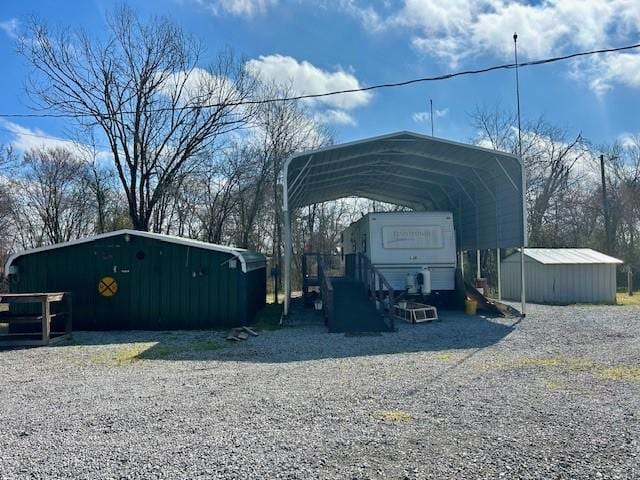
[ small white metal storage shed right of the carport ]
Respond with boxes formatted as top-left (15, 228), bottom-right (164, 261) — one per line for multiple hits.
top-left (501, 248), bottom-right (623, 305)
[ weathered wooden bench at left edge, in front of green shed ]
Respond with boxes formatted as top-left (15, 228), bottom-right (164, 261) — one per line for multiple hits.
top-left (0, 292), bottom-right (73, 347)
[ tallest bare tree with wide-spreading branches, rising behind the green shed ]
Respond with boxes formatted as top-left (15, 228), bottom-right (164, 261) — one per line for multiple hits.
top-left (19, 7), bottom-right (254, 230)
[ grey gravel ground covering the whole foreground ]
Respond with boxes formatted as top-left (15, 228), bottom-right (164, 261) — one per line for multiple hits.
top-left (0, 306), bottom-right (640, 479)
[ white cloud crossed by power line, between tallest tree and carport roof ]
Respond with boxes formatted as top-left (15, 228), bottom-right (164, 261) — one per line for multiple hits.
top-left (247, 55), bottom-right (372, 110)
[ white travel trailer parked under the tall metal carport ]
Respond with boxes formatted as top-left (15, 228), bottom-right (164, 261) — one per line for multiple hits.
top-left (342, 212), bottom-right (456, 294)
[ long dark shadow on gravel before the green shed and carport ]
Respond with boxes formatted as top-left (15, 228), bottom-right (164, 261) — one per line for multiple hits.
top-left (15, 302), bottom-right (515, 363)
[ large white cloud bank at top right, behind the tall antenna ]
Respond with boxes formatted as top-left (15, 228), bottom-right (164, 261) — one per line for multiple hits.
top-left (339, 0), bottom-right (640, 93)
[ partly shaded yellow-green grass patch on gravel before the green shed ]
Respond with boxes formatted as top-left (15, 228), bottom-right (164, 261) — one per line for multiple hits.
top-left (91, 340), bottom-right (224, 365)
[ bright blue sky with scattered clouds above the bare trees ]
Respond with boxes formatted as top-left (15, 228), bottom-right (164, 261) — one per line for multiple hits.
top-left (0, 0), bottom-right (640, 149)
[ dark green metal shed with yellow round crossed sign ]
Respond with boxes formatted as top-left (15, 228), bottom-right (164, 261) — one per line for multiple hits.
top-left (6, 230), bottom-right (266, 330)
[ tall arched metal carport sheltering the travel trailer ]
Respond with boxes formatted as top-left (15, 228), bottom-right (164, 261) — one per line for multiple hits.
top-left (283, 131), bottom-right (527, 315)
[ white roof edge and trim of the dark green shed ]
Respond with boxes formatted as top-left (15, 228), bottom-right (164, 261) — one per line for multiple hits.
top-left (5, 229), bottom-right (266, 275)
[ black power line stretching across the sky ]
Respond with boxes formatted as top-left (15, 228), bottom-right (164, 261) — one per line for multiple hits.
top-left (0, 43), bottom-right (640, 119)
